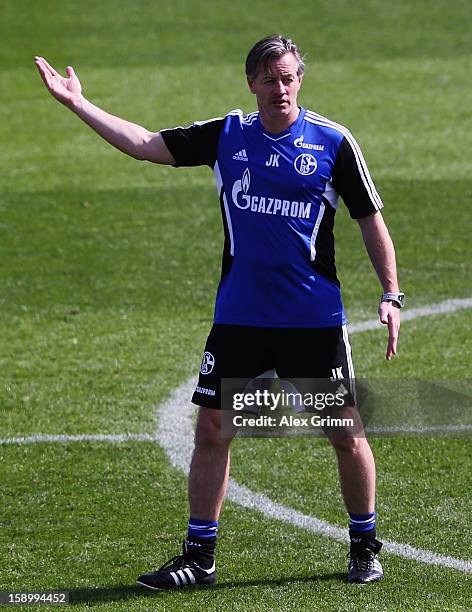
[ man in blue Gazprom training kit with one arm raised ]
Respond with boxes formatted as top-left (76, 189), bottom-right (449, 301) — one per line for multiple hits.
top-left (35, 36), bottom-right (404, 590)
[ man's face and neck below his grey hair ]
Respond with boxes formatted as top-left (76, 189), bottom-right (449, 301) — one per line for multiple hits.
top-left (248, 52), bottom-right (302, 132)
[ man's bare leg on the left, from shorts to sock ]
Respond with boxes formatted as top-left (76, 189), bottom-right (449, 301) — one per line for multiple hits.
top-left (188, 408), bottom-right (231, 521)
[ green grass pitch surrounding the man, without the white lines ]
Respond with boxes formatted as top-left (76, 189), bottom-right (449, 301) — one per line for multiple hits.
top-left (0, 0), bottom-right (472, 611)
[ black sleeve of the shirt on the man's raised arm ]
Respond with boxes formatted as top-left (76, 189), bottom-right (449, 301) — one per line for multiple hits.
top-left (161, 118), bottom-right (225, 168)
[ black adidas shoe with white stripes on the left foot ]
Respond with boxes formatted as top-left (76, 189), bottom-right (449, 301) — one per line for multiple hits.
top-left (136, 542), bottom-right (216, 591)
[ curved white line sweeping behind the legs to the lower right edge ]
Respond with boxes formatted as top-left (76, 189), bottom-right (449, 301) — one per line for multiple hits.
top-left (157, 378), bottom-right (472, 574)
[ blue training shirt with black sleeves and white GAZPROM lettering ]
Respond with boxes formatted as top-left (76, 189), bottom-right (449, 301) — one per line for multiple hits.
top-left (161, 108), bottom-right (383, 327)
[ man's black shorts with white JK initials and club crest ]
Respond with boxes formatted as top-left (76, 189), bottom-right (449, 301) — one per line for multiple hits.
top-left (192, 325), bottom-right (354, 408)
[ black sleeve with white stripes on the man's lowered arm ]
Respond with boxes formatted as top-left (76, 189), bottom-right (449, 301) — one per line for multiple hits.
top-left (332, 137), bottom-right (383, 219)
